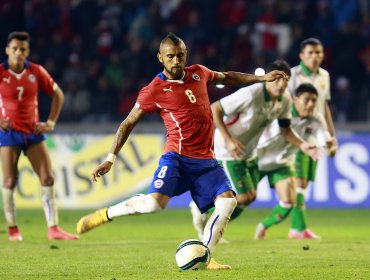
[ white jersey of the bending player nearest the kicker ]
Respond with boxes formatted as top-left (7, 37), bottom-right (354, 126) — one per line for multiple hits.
top-left (215, 83), bottom-right (292, 160)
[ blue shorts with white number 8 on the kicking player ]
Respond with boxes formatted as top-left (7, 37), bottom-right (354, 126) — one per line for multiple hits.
top-left (148, 152), bottom-right (232, 213)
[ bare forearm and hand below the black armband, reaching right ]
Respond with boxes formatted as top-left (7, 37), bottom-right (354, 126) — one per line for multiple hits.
top-left (280, 126), bottom-right (321, 160)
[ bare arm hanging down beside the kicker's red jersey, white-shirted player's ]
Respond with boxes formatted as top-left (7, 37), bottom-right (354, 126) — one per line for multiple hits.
top-left (211, 101), bottom-right (245, 160)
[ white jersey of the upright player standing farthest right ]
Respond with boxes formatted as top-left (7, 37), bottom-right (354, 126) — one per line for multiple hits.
top-left (288, 62), bottom-right (331, 116)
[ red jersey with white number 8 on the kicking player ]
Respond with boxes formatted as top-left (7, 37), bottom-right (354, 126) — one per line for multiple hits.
top-left (135, 65), bottom-right (217, 159)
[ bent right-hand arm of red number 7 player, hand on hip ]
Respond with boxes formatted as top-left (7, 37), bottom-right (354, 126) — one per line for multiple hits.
top-left (34, 84), bottom-right (64, 134)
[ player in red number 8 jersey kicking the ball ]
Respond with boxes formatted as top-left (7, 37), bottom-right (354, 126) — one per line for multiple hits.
top-left (77, 33), bottom-right (288, 270)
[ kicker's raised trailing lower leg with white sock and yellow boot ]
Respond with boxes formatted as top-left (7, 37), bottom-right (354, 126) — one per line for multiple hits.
top-left (77, 194), bottom-right (162, 233)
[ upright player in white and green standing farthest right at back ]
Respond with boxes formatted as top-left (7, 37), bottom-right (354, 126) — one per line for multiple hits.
top-left (288, 38), bottom-right (337, 239)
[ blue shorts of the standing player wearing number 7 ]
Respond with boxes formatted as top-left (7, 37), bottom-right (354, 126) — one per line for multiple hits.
top-left (0, 130), bottom-right (46, 153)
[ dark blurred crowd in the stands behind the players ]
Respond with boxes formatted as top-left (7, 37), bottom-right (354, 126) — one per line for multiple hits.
top-left (0, 0), bottom-right (370, 123)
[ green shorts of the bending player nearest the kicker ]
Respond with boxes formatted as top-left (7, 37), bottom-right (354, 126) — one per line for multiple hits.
top-left (218, 159), bottom-right (260, 194)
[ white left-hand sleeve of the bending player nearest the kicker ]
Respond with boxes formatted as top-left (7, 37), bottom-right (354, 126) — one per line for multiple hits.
top-left (219, 87), bottom-right (253, 116)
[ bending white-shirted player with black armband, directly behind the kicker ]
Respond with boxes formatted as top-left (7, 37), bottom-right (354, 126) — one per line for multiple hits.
top-left (190, 60), bottom-right (318, 241)
